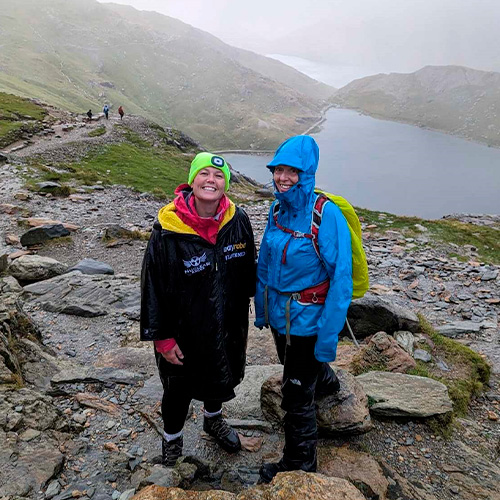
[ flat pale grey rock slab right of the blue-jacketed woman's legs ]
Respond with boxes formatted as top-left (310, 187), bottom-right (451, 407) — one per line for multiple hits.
top-left (356, 372), bottom-right (453, 418)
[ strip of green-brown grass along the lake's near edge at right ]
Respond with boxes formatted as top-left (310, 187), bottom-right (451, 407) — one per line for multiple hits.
top-left (356, 208), bottom-right (500, 264)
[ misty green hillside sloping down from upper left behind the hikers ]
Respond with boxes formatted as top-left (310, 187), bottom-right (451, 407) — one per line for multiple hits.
top-left (0, 0), bottom-right (335, 148)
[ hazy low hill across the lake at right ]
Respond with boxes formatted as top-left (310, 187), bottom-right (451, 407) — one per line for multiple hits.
top-left (334, 66), bottom-right (500, 146)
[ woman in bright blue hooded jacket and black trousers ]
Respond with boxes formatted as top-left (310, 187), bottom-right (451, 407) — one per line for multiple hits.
top-left (255, 135), bottom-right (352, 482)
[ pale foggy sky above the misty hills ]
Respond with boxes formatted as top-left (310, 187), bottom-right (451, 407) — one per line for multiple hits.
top-left (99, 0), bottom-right (500, 76)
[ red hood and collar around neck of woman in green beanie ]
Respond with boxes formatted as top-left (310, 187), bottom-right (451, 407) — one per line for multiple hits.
top-left (174, 184), bottom-right (229, 245)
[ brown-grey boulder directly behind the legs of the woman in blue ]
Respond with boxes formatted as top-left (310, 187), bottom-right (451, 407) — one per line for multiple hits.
top-left (261, 369), bottom-right (371, 436)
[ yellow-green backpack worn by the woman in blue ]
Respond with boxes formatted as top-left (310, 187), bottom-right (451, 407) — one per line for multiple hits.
top-left (311, 189), bottom-right (370, 299)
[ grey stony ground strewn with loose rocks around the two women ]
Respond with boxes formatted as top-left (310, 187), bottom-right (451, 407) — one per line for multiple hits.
top-left (0, 154), bottom-right (500, 500)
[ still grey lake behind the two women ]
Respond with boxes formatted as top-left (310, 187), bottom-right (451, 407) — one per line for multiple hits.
top-left (224, 109), bottom-right (500, 219)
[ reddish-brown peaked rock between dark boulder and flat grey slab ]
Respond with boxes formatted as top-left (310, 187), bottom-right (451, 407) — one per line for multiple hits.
top-left (351, 332), bottom-right (416, 374)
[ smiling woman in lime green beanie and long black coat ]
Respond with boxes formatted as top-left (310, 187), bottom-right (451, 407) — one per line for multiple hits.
top-left (140, 152), bottom-right (255, 467)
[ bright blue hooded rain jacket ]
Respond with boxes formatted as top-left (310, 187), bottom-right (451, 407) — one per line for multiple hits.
top-left (255, 135), bottom-right (352, 362)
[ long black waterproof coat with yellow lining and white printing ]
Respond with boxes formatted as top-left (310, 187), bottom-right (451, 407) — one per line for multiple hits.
top-left (141, 197), bottom-right (255, 401)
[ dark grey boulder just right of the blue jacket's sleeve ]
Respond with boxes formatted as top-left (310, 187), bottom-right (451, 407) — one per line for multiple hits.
top-left (341, 293), bottom-right (419, 337)
